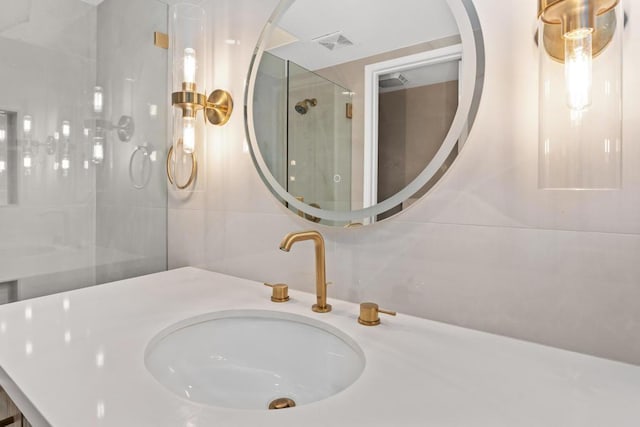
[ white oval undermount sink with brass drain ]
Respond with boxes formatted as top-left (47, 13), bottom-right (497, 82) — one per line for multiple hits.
top-left (145, 310), bottom-right (365, 410)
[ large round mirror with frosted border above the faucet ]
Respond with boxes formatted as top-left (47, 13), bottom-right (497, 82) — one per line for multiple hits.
top-left (245, 0), bottom-right (484, 226)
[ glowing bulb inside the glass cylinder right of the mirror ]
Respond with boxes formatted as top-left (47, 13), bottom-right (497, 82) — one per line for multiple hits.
top-left (564, 28), bottom-right (593, 111)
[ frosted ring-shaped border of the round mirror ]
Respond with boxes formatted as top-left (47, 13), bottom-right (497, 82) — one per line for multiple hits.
top-left (244, 0), bottom-right (485, 224)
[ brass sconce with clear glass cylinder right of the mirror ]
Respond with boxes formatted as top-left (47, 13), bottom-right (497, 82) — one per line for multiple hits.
top-left (538, 0), bottom-right (624, 190)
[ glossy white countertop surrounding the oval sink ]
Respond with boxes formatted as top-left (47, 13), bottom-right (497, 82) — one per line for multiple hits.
top-left (0, 268), bottom-right (640, 427)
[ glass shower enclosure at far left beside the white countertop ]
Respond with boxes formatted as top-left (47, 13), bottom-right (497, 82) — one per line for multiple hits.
top-left (0, 0), bottom-right (167, 304)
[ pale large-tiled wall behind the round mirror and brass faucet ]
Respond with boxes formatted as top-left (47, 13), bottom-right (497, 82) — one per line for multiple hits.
top-left (169, 0), bottom-right (640, 364)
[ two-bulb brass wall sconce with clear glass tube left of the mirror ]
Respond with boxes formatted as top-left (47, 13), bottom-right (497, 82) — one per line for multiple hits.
top-left (167, 3), bottom-right (233, 190)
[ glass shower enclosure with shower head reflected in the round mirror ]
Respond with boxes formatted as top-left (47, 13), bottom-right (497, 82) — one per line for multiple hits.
top-left (254, 52), bottom-right (353, 224)
